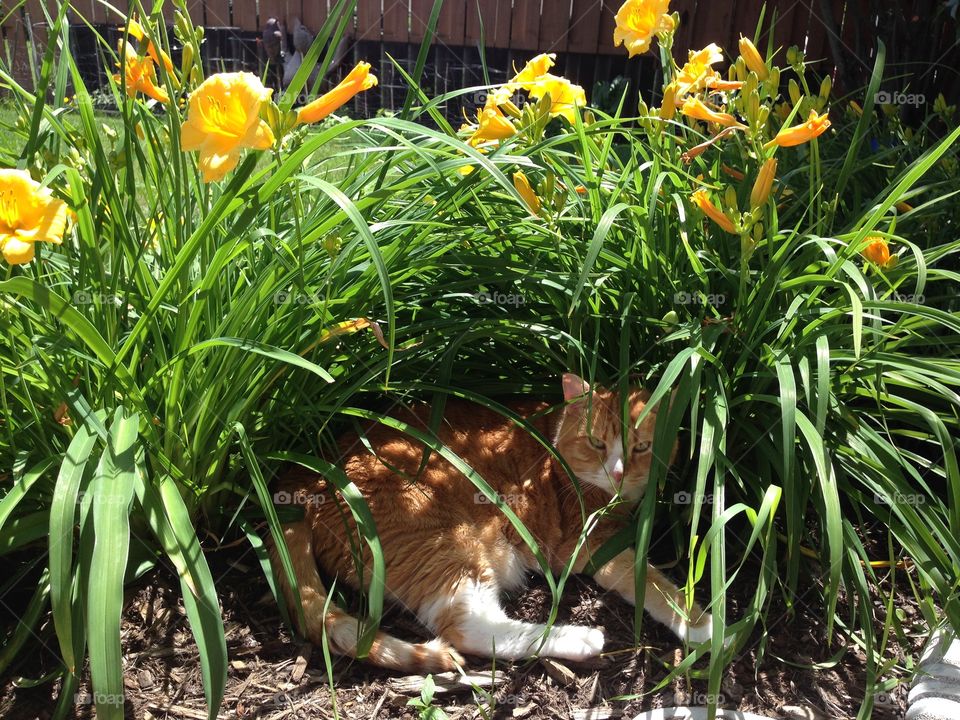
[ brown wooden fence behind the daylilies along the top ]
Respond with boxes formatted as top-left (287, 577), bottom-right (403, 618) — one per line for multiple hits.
top-left (0, 0), bottom-right (960, 118)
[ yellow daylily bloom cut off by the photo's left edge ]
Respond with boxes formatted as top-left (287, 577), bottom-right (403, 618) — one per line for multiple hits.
top-left (0, 168), bottom-right (72, 265)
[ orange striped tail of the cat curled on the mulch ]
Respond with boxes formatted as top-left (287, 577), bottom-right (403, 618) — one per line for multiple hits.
top-left (270, 521), bottom-right (465, 674)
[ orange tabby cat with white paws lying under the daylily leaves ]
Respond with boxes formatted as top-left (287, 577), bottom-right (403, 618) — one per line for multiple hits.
top-left (271, 374), bottom-right (712, 672)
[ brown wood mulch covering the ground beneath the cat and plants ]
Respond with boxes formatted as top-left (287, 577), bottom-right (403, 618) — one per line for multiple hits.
top-left (0, 547), bottom-right (925, 720)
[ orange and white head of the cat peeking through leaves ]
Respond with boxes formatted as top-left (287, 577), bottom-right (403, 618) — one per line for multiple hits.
top-left (555, 373), bottom-right (677, 501)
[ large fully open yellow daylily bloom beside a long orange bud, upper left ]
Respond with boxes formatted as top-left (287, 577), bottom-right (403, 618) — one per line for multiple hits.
top-left (180, 72), bottom-right (274, 182)
